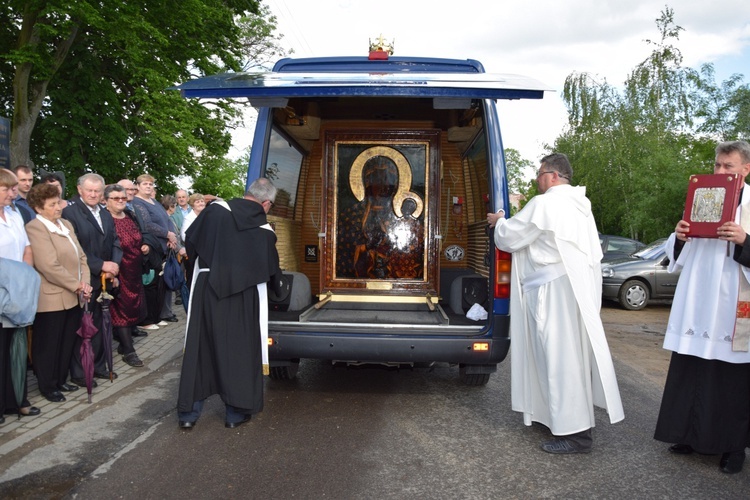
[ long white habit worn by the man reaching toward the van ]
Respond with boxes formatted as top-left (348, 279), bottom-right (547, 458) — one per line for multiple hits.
top-left (495, 184), bottom-right (625, 436)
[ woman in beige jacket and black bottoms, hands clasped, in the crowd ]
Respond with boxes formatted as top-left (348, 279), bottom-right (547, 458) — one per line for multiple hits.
top-left (26, 183), bottom-right (92, 403)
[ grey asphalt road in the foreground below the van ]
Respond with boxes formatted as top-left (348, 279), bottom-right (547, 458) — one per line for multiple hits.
top-left (0, 305), bottom-right (750, 499)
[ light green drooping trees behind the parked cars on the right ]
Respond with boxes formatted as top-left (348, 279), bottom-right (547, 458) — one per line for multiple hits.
top-left (554, 8), bottom-right (750, 242)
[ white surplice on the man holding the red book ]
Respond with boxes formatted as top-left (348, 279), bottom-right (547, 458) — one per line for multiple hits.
top-left (664, 184), bottom-right (750, 363)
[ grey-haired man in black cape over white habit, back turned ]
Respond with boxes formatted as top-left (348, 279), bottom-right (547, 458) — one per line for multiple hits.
top-left (177, 178), bottom-right (281, 429)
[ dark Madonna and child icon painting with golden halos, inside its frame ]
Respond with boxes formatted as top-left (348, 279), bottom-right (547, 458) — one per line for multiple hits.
top-left (336, 146), bottom-right (425, 280)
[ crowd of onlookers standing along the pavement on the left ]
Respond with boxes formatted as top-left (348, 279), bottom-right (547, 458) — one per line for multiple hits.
top-left (0, 165), bottom-right (205, 423)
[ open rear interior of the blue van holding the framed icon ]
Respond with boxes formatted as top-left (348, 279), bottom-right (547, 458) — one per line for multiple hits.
top-left (265, 96), bottom-right (490, 331)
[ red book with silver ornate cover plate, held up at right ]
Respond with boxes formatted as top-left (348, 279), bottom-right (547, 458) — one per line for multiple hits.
top-left (683, 174), bottom-right (743, 238)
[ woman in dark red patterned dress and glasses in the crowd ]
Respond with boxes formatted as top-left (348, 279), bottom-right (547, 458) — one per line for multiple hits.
top-left (104, 184), bottom-right (151, 367)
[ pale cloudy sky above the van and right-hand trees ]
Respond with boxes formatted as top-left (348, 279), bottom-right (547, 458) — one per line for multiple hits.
top-left (232, 0), bottom-right (750, 163)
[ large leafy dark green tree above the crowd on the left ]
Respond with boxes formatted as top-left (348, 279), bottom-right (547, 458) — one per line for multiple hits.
top-left (0, 0), bottom-right (288, 188)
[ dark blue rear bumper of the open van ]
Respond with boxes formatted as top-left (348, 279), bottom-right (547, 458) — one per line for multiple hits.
top-left (268, 315), bottom-right (510, 365)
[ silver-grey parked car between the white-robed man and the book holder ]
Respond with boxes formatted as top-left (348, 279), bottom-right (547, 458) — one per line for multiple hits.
top-left (602, 238), bottom-right (680, 311)
